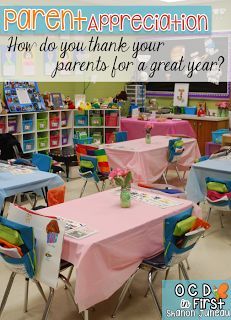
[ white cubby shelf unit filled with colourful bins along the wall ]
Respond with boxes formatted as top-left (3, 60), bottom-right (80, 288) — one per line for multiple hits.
top-left (0, 109), bottom-right (120, 153)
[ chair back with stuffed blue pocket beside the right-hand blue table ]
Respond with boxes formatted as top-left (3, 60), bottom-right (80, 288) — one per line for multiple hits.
top-left (205, 177), bottom-right (231, 211)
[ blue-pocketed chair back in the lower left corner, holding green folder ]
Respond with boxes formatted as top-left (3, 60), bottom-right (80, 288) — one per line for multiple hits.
top-left (0, 216), bottom-right (36, 278)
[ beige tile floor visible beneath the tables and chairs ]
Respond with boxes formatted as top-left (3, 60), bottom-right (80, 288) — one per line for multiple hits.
top-left (0, 176), bottom-right (231, 320)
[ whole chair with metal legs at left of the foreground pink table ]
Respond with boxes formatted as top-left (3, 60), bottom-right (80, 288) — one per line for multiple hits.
top-left (0, 211), bottom-right (76, 320)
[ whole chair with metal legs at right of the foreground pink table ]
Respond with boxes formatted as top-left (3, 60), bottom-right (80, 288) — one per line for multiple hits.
top-left (112, 208), bottom-right (209, 318)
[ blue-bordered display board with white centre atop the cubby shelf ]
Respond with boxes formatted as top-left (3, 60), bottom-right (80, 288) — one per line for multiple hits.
top-left (3, 81), bottom-right (46, 113)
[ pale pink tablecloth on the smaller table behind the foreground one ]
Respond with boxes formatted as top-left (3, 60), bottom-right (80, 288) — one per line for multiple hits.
top-left (105, 136), bottom-right (200, 183)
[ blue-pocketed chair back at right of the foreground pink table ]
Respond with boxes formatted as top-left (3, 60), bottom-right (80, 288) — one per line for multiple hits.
top-left (164, 207), bottom-right (205, 266)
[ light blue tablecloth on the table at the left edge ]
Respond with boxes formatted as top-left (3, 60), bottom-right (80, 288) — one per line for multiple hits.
top-left (0, 170), bottom-right (64, 208)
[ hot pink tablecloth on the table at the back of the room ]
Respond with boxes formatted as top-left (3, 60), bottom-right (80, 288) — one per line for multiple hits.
top-left (121, 118), bottom-right (196, 140)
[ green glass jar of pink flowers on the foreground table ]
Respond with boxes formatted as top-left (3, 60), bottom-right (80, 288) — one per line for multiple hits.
top-left (109, 169), bottom-right (132, 208)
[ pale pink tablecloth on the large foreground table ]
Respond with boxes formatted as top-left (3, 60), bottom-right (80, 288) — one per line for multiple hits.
top-left (41, 189), bottom-right (200, 311)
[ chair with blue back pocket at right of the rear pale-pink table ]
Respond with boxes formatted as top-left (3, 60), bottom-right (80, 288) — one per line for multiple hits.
top-left (163, 138), bottom-right (184, 184)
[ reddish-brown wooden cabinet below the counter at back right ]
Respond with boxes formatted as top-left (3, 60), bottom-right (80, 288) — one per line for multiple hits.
top-left (187, 119), bottom-right (229, 155)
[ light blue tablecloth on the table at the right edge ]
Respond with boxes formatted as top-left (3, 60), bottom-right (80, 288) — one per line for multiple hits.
top-left (186, 159), bottom-right (231, 203)
